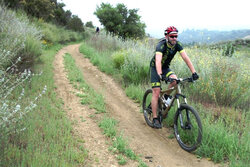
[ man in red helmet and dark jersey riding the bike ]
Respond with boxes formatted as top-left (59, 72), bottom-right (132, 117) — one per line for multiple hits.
top-left (150, 26), bottom-right (199, 128)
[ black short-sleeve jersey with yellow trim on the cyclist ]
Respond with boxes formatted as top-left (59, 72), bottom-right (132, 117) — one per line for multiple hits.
top-left (150, 38), bottom-right (184, 69)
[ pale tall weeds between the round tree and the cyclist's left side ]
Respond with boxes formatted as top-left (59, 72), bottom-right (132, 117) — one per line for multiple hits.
top-left (85, 34), bottom-right (153, 85)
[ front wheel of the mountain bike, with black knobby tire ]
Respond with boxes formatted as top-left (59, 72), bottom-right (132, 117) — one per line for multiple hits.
top-left (174, 104), bottom-right (202, 152)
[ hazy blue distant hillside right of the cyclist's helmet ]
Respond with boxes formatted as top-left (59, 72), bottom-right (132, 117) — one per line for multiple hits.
top-left (179, 29), bottom-right (250, 44)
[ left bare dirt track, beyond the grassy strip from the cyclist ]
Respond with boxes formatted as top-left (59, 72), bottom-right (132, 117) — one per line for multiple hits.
top-left (53, 46), bottom-right (137, 167)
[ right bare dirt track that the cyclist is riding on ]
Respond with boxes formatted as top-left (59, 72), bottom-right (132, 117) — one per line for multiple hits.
top-left (55, 44), bottom-right (223, 167)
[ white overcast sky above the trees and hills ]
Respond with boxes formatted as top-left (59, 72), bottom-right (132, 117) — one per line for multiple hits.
top-left (58, 0), bottom-right (250, 37)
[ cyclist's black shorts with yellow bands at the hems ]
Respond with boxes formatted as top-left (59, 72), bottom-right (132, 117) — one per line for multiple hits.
top-left (150, 67), bottom-right (174, 88)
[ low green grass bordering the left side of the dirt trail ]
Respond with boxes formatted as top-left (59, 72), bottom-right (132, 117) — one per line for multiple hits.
top-left (0, 46), bottom-right (87, 166)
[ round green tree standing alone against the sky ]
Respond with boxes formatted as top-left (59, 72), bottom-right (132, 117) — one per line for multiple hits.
top-left (94, 3), bottom-right (146, 39)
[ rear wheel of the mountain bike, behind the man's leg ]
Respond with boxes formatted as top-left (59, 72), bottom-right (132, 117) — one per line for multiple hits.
top-left (142, 89), bottom-right (160, 128)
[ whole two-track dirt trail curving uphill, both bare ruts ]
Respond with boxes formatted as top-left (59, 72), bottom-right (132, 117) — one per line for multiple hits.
top-left (54, 44), bottom-right (219, 167)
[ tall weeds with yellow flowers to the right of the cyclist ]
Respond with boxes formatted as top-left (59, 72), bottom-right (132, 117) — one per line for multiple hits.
top-left (168, 47), bottom-right (250, 110)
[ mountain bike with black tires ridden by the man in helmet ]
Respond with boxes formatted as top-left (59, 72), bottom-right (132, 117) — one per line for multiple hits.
top-left (142, 77), bottom-right (202, 152)
